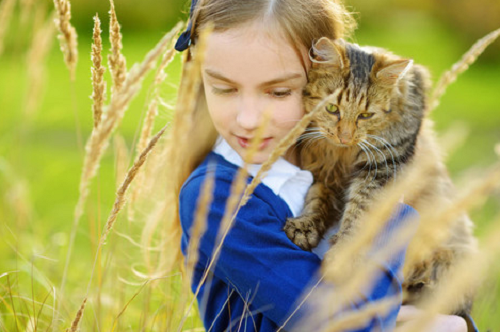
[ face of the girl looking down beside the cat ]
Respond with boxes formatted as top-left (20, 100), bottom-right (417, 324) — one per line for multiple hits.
top-left (202, 22), bottom-right (309, 164)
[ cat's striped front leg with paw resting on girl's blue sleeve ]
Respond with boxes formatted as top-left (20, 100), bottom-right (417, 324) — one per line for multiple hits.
top-left (284, 182), bottom-right (335, 250)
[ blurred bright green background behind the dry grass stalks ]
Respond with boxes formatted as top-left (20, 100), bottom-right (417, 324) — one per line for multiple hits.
top-left (0, 0), bottom-right (500, 331)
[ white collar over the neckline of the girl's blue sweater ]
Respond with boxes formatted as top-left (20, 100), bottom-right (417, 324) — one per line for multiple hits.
top-left (213, 136), bottom-right (313, 216)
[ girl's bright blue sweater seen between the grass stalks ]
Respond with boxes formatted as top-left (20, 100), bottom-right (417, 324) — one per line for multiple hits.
top-left (180, 168), bottom-right (413, 331)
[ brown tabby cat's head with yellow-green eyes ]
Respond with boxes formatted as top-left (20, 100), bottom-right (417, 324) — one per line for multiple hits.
top-left (304, 38), bottom-right (412, 147)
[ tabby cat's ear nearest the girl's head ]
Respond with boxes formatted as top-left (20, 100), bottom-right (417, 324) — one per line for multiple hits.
top-left (309, 37), bottom-right (345, 69)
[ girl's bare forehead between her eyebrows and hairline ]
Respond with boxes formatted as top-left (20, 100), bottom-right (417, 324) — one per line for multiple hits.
top-left (203, 24), bottom-right (309, 82)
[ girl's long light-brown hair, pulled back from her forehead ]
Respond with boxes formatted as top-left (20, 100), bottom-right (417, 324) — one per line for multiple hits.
top-left (148, 0), bottom-right (355, 269)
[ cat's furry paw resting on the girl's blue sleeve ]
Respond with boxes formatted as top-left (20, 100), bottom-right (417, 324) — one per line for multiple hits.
top-left (284, 215), bottom-right (321, 251)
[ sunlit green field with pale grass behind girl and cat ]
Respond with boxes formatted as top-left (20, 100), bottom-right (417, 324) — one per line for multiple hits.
top-left (0, 0), bottom-right (500, 332)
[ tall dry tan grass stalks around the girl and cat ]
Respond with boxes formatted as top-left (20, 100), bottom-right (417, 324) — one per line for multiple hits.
top-left (0, 0), bottom-right (500, 331)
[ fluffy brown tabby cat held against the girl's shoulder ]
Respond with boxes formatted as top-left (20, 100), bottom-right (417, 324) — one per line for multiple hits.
top-left (285, 38), bottom-right (476, 314)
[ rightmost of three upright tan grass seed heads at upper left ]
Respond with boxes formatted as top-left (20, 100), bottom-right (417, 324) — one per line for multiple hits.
top-left (108, 0), bottom-right (127, 94)
